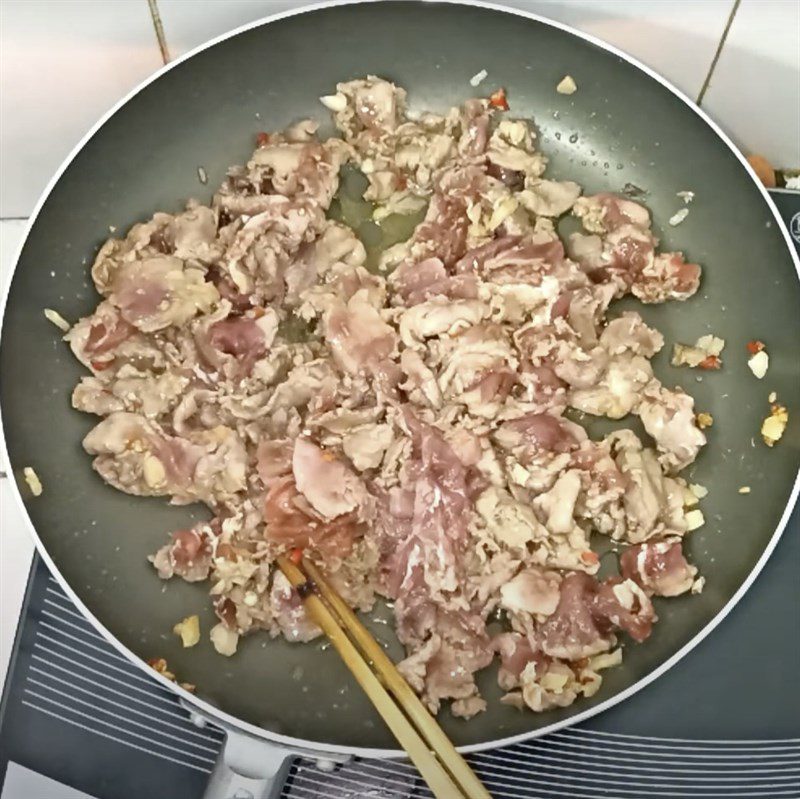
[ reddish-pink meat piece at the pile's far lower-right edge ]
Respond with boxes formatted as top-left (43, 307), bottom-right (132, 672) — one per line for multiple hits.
top-left (619, 541), bottom-right (697, 596)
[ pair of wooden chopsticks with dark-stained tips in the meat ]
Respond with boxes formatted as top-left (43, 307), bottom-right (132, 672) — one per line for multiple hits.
top-left (278, 557), bottom-right (491, 799)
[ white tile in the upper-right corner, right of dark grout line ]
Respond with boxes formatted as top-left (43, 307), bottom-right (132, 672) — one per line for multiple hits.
top-left (703, 0), bottom-right (800, 167)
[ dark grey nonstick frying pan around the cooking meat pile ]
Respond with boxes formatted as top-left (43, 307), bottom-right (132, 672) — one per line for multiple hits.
top-left (0, 2), bottom-right (800, 792)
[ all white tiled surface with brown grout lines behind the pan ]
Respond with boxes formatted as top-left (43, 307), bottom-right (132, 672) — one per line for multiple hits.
top-left (0, 0), bottom-right (800, 680)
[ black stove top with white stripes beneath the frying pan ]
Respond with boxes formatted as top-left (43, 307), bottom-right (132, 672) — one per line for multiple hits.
top-left (0, 192), bottom-right (800, 799)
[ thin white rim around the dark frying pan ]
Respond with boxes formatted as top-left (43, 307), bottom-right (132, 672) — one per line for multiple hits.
top-left (0, 0), bottom-right (800, 759)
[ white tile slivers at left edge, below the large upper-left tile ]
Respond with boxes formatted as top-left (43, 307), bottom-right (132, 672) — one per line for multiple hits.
top-left (0, 220), bottom-right (33, 685)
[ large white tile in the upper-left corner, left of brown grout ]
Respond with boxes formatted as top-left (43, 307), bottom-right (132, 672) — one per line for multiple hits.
top-left (0, 0), bottom-right (162, 217)
